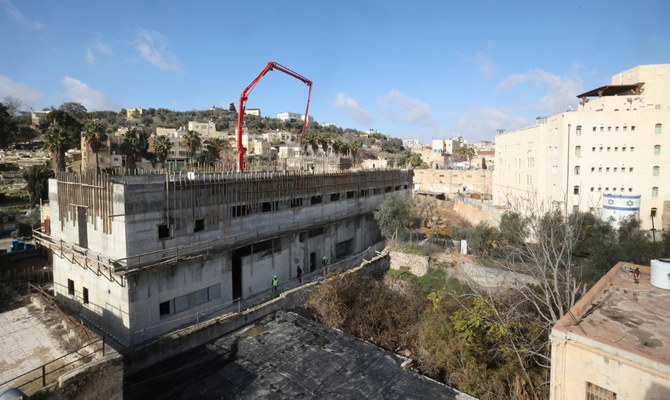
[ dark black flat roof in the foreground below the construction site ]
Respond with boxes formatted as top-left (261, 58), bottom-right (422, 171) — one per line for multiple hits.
top-left (124, 311), bottom-right (472, 400)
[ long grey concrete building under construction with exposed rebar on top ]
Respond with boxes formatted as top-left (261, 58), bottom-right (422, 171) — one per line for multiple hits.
top-left (38, 170), bottom-right (412, 346)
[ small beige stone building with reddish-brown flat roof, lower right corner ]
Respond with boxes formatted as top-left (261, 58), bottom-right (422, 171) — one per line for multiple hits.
top-left (550, 260), bottom-right (670, 400)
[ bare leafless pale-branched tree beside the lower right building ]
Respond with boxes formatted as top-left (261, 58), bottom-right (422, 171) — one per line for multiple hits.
top-left (454, 197), bottom-right (586, 398)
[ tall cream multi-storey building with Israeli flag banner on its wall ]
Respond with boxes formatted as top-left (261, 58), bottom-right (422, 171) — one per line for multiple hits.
top-left (493, 64), bottom-right (670, 230)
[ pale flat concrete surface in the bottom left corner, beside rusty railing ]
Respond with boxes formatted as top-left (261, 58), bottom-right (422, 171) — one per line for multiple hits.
top-left (0, 306), bottom-right (76, 393)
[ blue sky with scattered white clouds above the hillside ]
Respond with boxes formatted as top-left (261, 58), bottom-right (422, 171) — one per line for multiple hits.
top-left (0, 0), bottom-right (670, 142)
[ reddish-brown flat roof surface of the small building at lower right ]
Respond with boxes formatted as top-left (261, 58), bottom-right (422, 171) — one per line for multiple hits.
top-left (554, 262), bottom-right (670, 366)
